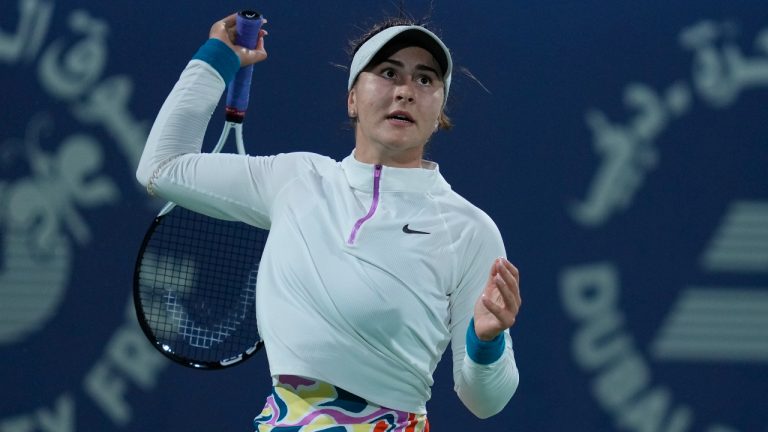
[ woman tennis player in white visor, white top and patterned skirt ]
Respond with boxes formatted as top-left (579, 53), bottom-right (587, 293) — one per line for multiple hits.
top-left (137, 11), bottom-right (521, 431)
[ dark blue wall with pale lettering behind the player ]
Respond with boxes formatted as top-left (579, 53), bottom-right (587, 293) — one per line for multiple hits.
top-left (0, 0), bottom-right (768, 432)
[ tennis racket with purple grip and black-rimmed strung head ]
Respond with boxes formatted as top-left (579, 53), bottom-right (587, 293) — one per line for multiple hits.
top-left (133, 11), bottom-right (267, 369)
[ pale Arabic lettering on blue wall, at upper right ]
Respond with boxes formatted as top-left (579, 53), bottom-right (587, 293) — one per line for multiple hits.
top-left (570, 21), bottom-right (768, 228)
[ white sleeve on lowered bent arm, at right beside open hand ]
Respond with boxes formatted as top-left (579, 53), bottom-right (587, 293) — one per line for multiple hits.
top-left (450, 215), bottom-right (519, 418)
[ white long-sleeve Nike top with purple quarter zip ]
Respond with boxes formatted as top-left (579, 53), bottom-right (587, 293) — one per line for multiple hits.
top-left (137, 41), bottom-right (518, 418)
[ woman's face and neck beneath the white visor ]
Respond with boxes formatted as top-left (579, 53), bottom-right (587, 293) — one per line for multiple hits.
top-left (347, 47), bottom-right (445, 167)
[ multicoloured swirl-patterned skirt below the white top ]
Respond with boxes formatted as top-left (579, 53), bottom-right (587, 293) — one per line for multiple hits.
top-left (253, 375), bottom-right (429, 432)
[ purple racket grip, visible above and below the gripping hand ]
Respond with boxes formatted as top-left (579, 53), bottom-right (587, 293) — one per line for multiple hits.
top-left (226, 10), bottom-right (264, 123)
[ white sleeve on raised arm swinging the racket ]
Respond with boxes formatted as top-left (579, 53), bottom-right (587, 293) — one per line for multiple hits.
top-left (136, 60), bottom-right (317, 229)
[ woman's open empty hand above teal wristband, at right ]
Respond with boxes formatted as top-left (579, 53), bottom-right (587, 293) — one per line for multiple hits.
top-left (475, 258), bottom-right (522, 341)
